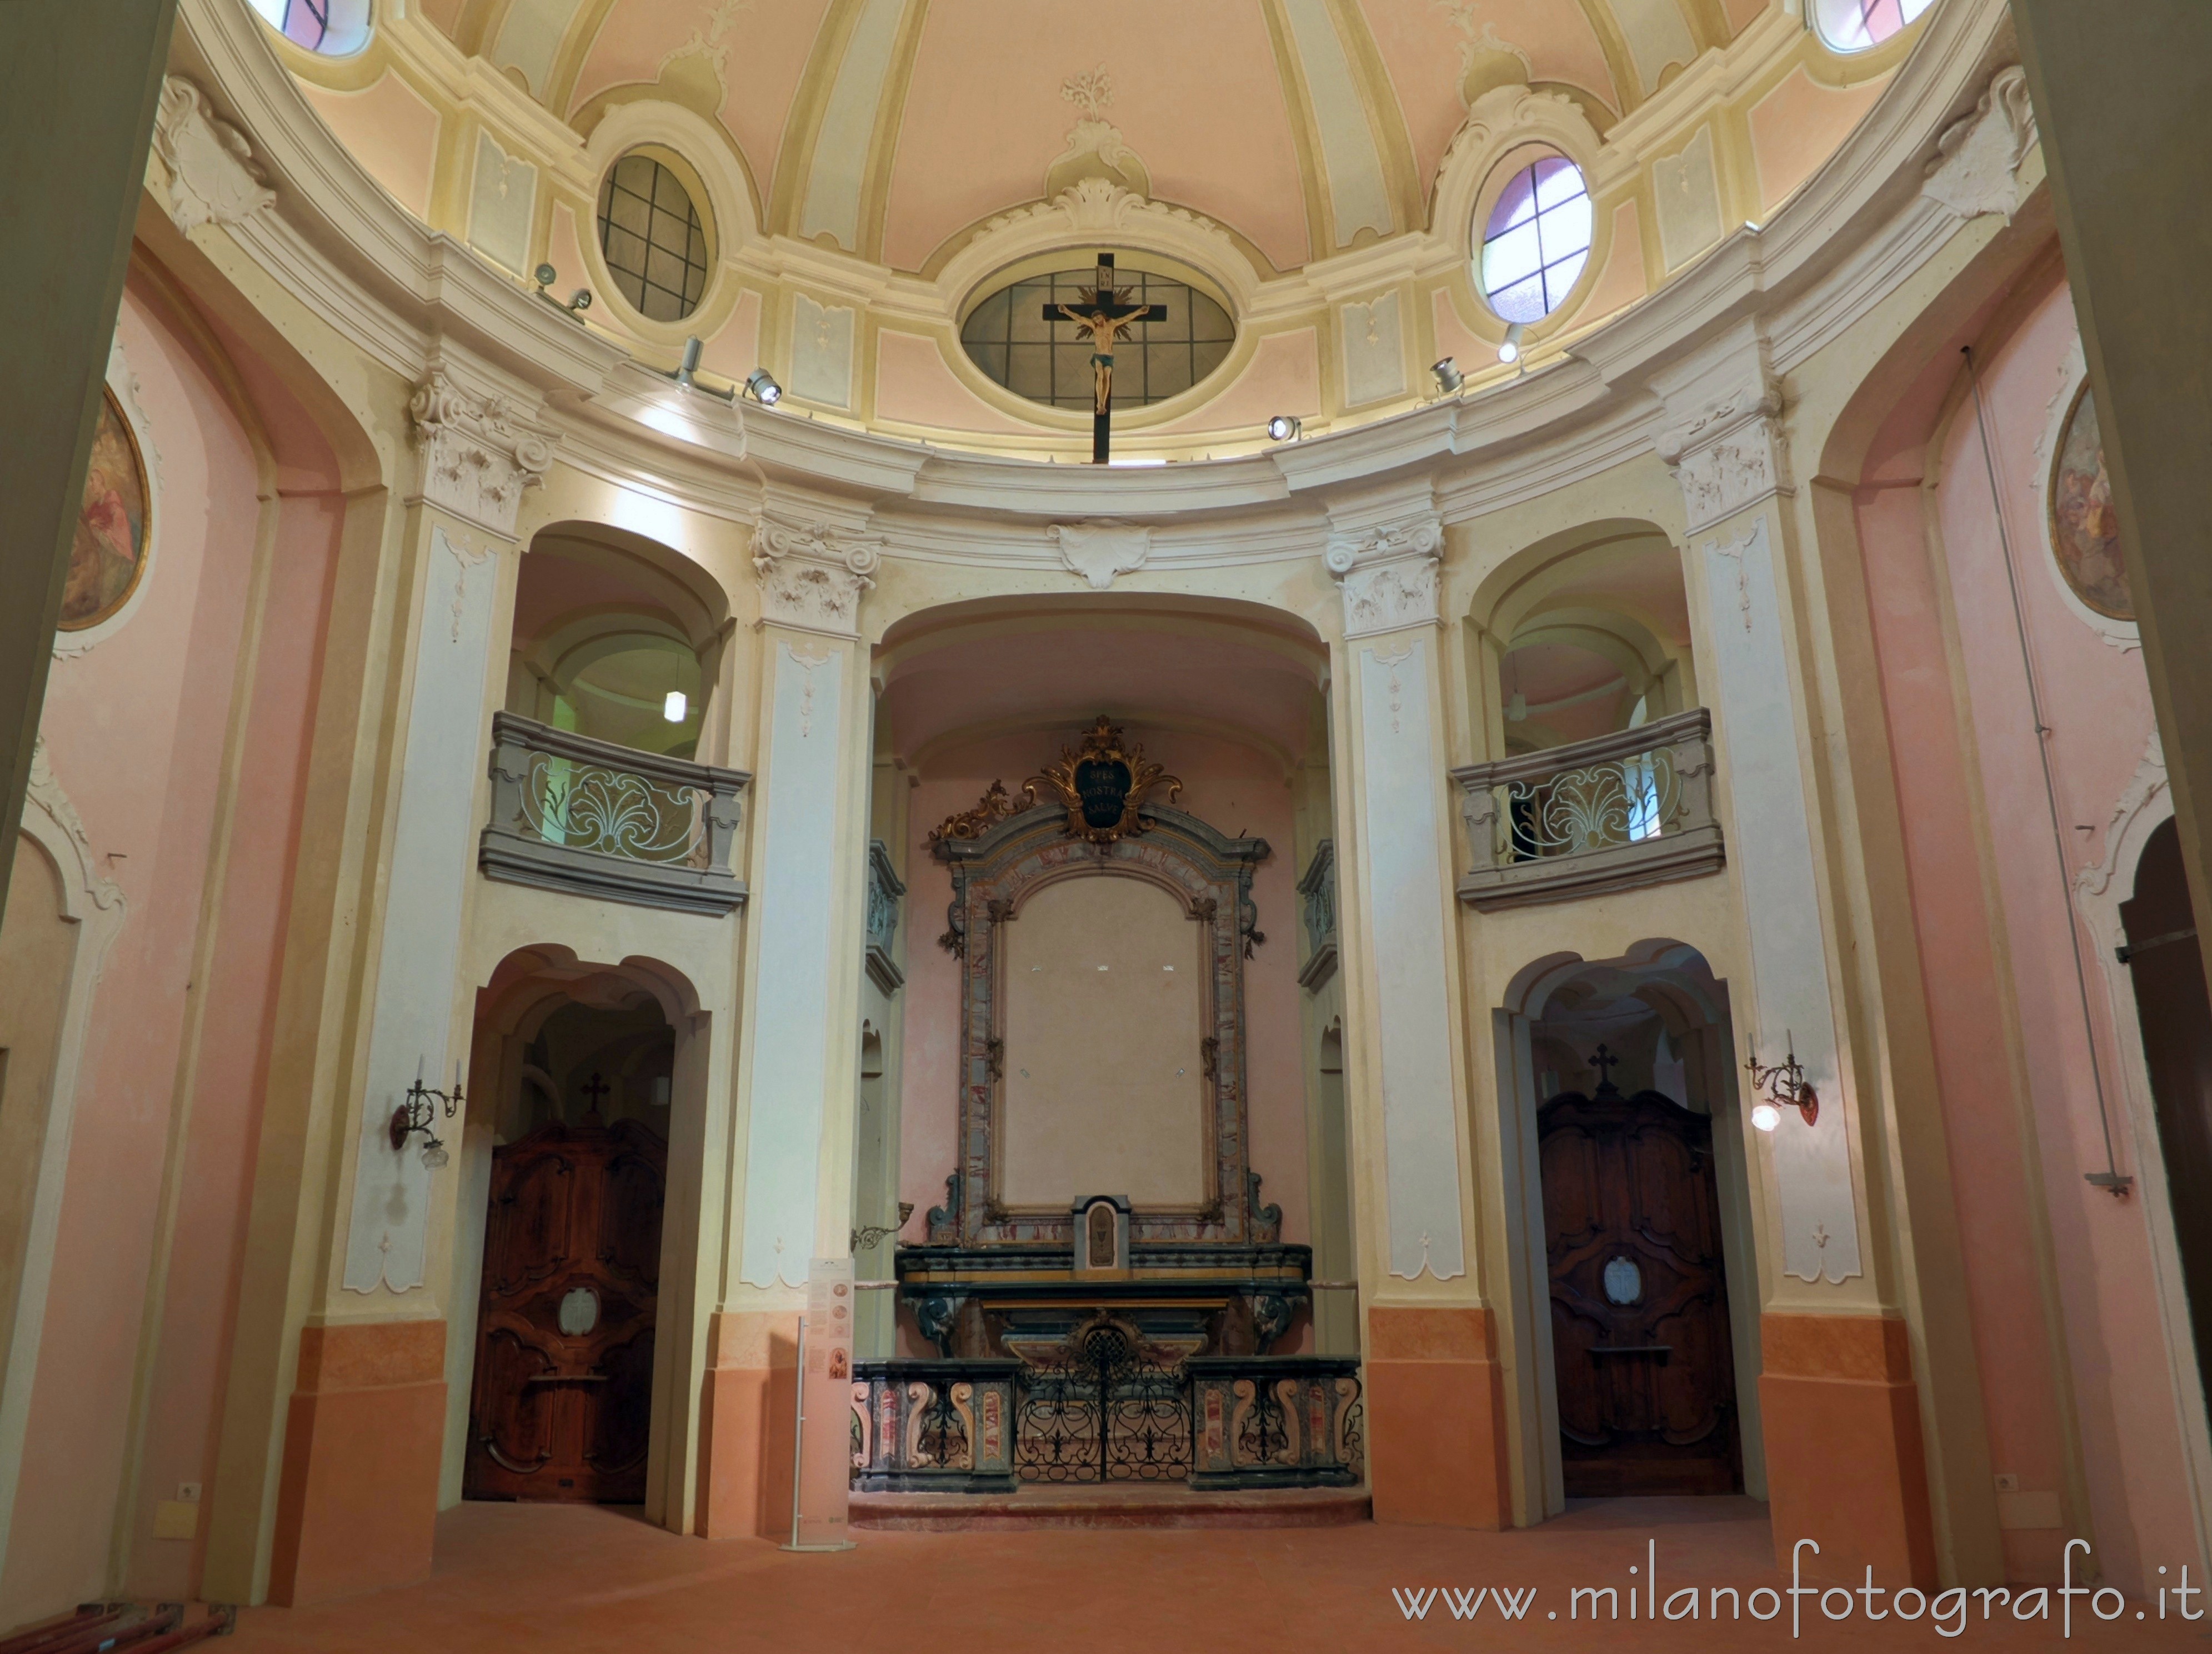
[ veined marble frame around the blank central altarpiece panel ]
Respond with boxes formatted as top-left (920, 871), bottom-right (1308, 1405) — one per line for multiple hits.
top-left (929, 805), bottom-right (1283, 1247)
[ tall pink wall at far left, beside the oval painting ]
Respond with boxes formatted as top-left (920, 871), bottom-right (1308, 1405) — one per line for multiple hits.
top-left (4, 278), bottom-right (341, 1612)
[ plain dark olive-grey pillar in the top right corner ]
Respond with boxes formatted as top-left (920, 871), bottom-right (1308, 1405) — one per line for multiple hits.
top-left (2013, 0), bottom-right (2212, 1012)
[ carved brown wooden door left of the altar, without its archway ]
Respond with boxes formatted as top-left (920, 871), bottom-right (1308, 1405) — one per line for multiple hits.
top-left (462, 1121), bottom-right (668, 1503)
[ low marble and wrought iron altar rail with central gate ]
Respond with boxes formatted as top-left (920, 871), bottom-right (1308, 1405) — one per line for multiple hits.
top-left (852, 1353), bottom-right (1365, 1492)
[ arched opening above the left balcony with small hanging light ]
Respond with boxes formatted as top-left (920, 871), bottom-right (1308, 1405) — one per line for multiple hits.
top-left (507, 524), bottom-right (725, 761)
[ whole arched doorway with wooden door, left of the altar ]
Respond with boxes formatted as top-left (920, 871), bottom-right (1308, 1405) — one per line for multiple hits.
top-left (447, 946), bottom-right (705, 1526)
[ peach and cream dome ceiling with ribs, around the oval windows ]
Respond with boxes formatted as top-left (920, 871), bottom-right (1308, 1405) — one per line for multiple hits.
top-left (281, 0), bottom-right (1918, 458)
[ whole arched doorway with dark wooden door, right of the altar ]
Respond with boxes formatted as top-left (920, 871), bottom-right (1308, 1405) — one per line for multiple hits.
top-left (1500, 942), bottom-right (1765, 1515)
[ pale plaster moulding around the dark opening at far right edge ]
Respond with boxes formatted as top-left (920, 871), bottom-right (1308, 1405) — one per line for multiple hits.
top-left (2073, 729), bottom-right (2212, 1557)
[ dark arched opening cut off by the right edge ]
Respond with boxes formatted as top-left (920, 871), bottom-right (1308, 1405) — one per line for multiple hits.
top-left (2119, 816), bottom-right (2212, 1376)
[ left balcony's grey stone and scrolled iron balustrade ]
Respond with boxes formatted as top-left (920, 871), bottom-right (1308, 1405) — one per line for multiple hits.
top-left (476, 712), bottom-right (752, 913)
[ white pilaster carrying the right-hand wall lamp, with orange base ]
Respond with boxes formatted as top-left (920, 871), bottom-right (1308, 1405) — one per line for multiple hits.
top-left (1657, 323), bottom-right (1935, 1586)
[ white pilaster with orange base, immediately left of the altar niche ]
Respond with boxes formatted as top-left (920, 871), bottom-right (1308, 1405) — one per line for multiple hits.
top-left (697, 511), bottom-right (880, 1539)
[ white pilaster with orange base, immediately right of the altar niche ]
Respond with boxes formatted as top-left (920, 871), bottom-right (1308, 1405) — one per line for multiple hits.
top-left (1325, 491), bottom-right (1513, 1528)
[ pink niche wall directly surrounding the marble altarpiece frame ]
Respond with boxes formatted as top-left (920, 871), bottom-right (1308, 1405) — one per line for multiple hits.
top-left (900, 723), bottom-right (1312, 1326)
